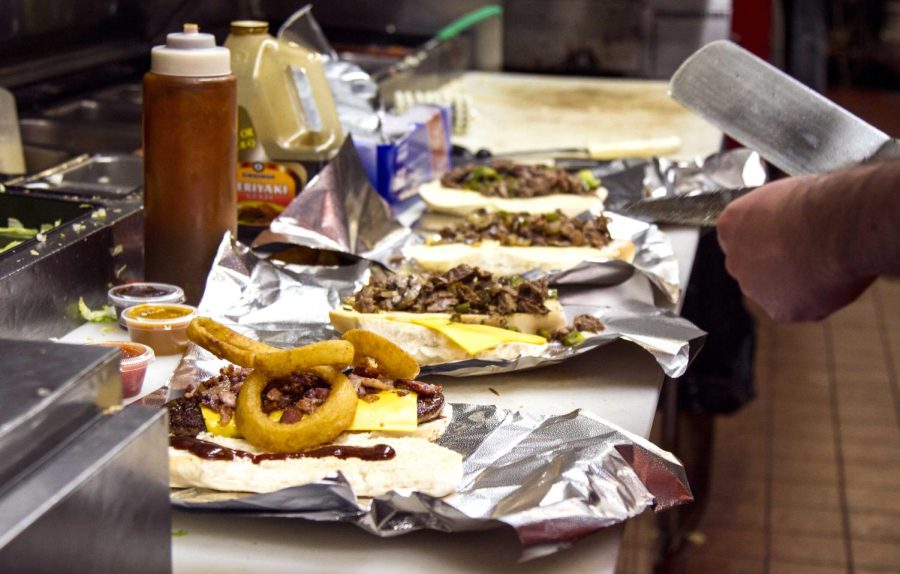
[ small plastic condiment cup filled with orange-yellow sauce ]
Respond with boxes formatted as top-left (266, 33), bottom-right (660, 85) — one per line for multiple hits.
top-left (122, 303), bottom-right (197, 355)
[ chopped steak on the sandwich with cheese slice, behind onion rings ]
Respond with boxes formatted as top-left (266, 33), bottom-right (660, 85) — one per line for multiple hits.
top-left (349, 265), bottom-right (550, 320)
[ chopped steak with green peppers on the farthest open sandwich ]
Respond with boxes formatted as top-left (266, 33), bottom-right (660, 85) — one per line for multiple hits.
top-left (441, 161), bottom-right (600, 197)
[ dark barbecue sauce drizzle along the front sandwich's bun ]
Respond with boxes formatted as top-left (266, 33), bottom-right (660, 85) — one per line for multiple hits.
top-left (169, 436), bottom-right (397, 464)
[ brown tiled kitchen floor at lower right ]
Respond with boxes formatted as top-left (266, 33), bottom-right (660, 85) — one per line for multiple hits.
top-left (618, 280), bottom-right (900, 574)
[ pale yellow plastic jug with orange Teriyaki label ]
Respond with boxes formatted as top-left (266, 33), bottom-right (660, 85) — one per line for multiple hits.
top-left (225, 20), bottom-right (344, 238)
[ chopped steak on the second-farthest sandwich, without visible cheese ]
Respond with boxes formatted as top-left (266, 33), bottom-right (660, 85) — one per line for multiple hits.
top-left (434, 210), bottom-right (612, 249)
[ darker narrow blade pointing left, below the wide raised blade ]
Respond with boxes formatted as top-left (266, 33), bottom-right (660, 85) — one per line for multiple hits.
top-left (618, 187), bottom-right (756, 227)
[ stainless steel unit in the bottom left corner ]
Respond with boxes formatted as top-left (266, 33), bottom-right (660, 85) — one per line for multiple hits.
top-left (0, 340), bottom-right (171, 574)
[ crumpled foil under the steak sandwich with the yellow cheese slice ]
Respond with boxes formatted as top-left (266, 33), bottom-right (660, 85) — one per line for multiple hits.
top-left (186, 235), bottom-right (705, 387)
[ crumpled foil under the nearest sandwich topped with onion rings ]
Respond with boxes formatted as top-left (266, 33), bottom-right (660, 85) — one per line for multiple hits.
top-left (172, 404), bottom-right (693, 560)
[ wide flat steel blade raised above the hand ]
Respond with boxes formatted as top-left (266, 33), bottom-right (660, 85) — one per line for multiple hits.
top-left (669, 40), bottom-right (900, 175)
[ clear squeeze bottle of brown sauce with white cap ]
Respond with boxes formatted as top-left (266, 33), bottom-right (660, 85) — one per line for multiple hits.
top-left (143, 24), bottom-right (237, 305)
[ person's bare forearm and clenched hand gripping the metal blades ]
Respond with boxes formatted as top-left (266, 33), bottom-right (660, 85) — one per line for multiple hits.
top-left (717, 161), bottom-right (900, 321)
